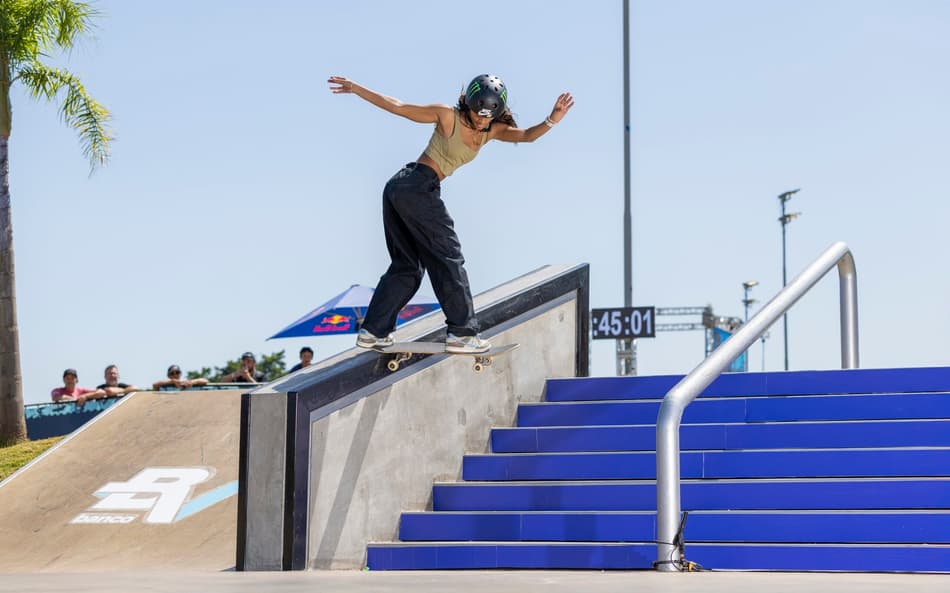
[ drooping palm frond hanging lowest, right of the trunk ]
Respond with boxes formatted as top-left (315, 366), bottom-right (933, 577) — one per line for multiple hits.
top-left (19, 62), bottom-right (113, 170)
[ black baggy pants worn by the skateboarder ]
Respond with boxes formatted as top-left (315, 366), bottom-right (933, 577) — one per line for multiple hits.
top-left (363, 163), bottom-right (478, 337)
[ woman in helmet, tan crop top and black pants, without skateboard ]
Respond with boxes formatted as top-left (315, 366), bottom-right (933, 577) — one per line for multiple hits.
top-left (328, 74), bottom-right (574, 353)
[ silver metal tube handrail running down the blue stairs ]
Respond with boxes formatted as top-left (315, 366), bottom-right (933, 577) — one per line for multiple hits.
top-left (656, 242), bottom-right (858, 571)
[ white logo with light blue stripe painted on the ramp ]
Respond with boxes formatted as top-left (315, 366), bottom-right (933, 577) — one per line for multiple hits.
top-left (70, 467), bottom-right (237, 524)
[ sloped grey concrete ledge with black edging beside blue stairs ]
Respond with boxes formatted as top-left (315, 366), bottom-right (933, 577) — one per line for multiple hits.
top-left (237, 264), bottom-right (590, 570)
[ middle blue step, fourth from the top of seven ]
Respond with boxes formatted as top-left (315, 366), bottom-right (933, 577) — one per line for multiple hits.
top-left (462, 449), bottom-right (950, 481)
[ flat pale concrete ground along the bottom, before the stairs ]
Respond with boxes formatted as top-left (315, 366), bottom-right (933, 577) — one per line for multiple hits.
top-left (0, 570), bottom-right (950, 593)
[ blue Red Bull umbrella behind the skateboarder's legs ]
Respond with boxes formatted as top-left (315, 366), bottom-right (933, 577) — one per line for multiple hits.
top-left (267, 284), bottom-right (439, 340)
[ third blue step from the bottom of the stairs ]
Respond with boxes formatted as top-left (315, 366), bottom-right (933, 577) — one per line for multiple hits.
top-left (432, 478), bottom-right (950, 511)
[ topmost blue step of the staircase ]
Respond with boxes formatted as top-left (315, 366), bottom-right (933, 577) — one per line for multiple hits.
top-left (544, 367), bottom-right (950, 402)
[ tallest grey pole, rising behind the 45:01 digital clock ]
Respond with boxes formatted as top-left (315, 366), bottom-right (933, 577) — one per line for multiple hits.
top-left (617, 0), bottom-right (637, 375)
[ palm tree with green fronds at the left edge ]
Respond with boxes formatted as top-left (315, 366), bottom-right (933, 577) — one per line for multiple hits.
top-left (0, 0), bottom-right (112, 443)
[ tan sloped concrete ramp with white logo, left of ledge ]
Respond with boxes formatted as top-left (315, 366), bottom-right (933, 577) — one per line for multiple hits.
top-left (0, 391), bottom-right (241, 572)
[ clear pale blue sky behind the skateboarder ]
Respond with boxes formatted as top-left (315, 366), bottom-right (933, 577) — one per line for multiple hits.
top-left (11, 0), bottom-right (950, 403)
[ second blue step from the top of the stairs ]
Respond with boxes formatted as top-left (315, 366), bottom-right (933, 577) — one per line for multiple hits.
top-left (518, 393), bottom-right (950, 426)
